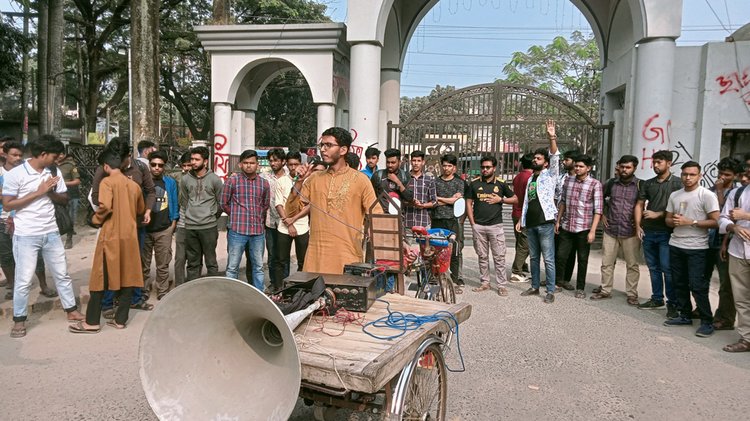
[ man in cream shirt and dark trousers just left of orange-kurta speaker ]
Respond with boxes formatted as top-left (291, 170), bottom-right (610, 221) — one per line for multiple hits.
top-left (270, 151), bottom-right (310, 291)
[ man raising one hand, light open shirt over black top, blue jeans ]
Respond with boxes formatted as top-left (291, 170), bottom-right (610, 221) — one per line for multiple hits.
top-left (515, 120), bottom-right (560, 303)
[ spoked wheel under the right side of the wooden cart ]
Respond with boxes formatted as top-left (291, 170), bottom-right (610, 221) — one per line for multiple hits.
top-left (389, 336), bottom-right (448, 421)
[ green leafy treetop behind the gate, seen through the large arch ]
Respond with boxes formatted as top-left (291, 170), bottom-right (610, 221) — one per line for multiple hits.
top-left (499, 31), bottom-right (601, 116)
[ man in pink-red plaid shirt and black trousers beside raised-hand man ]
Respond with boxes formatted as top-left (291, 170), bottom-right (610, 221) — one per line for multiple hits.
top-left (555, 155), bottom-right (603, 298)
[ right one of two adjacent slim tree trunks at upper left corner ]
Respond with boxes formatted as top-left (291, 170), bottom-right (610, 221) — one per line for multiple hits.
top-left (46, 0), bottom-right (65, 137)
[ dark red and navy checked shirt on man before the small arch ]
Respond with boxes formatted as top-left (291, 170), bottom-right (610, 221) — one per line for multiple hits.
top-left (221, 173), bottom-right (271, 235)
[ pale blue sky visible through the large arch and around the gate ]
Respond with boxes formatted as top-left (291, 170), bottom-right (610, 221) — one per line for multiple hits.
top-left (0, 0), bottom-right (750, 97)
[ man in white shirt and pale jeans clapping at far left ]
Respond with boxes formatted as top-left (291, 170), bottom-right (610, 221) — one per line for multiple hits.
top-left (3, 139), bottom-right (84, 338)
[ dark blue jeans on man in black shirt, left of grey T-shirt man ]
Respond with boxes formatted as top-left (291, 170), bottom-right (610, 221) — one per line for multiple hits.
top-left (643, 231), bottom-right (680, 304)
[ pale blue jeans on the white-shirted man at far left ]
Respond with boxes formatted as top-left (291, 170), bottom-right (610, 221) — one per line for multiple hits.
top-left (13, 232), bottom-right (77, 322)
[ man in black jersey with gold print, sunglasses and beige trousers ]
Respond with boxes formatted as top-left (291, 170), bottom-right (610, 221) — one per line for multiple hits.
top-left (466, 156), bottom-right (518, 297)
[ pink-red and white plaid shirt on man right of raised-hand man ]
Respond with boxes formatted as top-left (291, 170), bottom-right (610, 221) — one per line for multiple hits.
top-left (560, 175), bottom-right (603, 233)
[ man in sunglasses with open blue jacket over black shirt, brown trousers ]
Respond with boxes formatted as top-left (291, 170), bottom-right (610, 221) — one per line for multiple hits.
top-left (141, 151), bottom-right (180, 300)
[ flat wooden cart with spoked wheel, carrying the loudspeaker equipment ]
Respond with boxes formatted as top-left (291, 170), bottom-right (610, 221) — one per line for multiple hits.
top-left (295, 294), bottom-right (471, 420)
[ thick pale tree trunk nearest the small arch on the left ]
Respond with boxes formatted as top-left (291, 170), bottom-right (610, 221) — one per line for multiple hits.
top-left (130, 0), bottom-right (160, 145)
